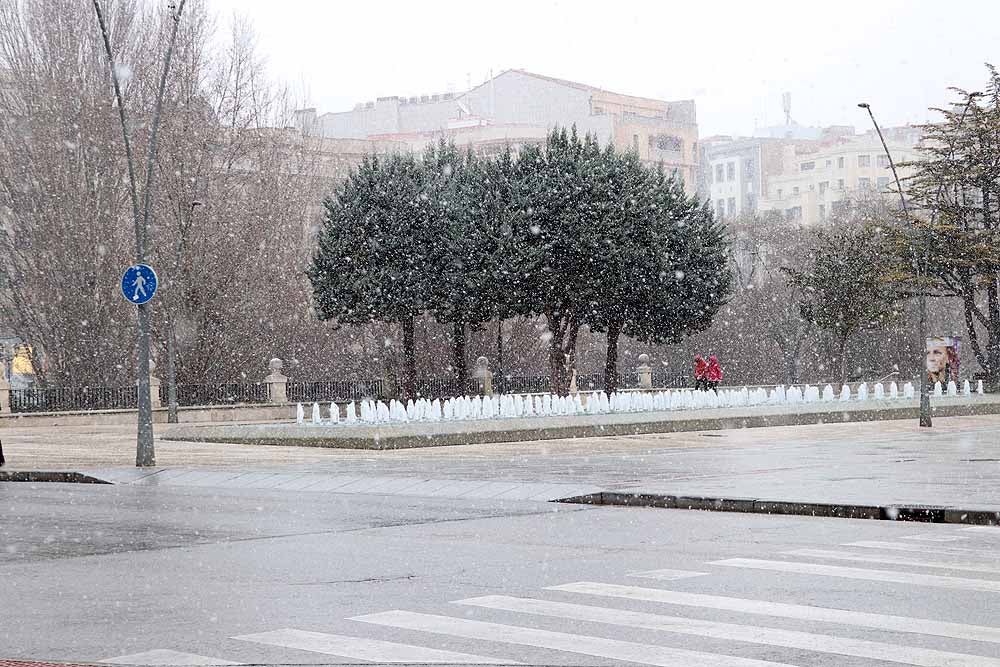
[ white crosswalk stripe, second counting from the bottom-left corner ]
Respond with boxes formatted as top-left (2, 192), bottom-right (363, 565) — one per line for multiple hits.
top-left (233, 628), bottom-right (521, 665)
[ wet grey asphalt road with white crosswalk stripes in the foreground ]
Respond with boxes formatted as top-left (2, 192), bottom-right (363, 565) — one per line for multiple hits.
top-left (0, 483), bottom-right (1000, 666)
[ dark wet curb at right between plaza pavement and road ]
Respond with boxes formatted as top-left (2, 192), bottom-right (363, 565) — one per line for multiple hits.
top-left (554, 491), bottom-right (1000, 526)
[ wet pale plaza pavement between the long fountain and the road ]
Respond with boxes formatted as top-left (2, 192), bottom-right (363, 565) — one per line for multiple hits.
top-left (0, 415), bottom-right (1000, 512)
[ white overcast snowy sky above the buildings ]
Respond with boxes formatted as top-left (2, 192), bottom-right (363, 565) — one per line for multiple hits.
top-left (207, 0), bottom-right (1000, 136)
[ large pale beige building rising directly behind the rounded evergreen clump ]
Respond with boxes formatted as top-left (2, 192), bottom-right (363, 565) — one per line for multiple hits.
top-left (295, 70), bottom-right (698, 193)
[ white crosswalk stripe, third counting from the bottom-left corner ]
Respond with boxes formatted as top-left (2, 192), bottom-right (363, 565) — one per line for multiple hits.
top-left (351, 610), bottom-right (789, 667)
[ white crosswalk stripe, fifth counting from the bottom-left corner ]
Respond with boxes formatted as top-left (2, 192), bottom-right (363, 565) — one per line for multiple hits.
top-left (547, 581), bottom-right (1000, 644)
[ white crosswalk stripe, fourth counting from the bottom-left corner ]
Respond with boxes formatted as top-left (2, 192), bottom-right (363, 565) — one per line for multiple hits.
top-left (457, 595), bottom-right (1000, 667)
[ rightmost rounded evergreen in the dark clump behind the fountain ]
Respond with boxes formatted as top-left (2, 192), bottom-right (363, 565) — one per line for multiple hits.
top-left (587, 155), bottom-right (733, 393)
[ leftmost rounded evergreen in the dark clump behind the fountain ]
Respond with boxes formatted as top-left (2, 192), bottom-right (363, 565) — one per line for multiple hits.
top-left (307, 154), bottom-right (435, 397)
